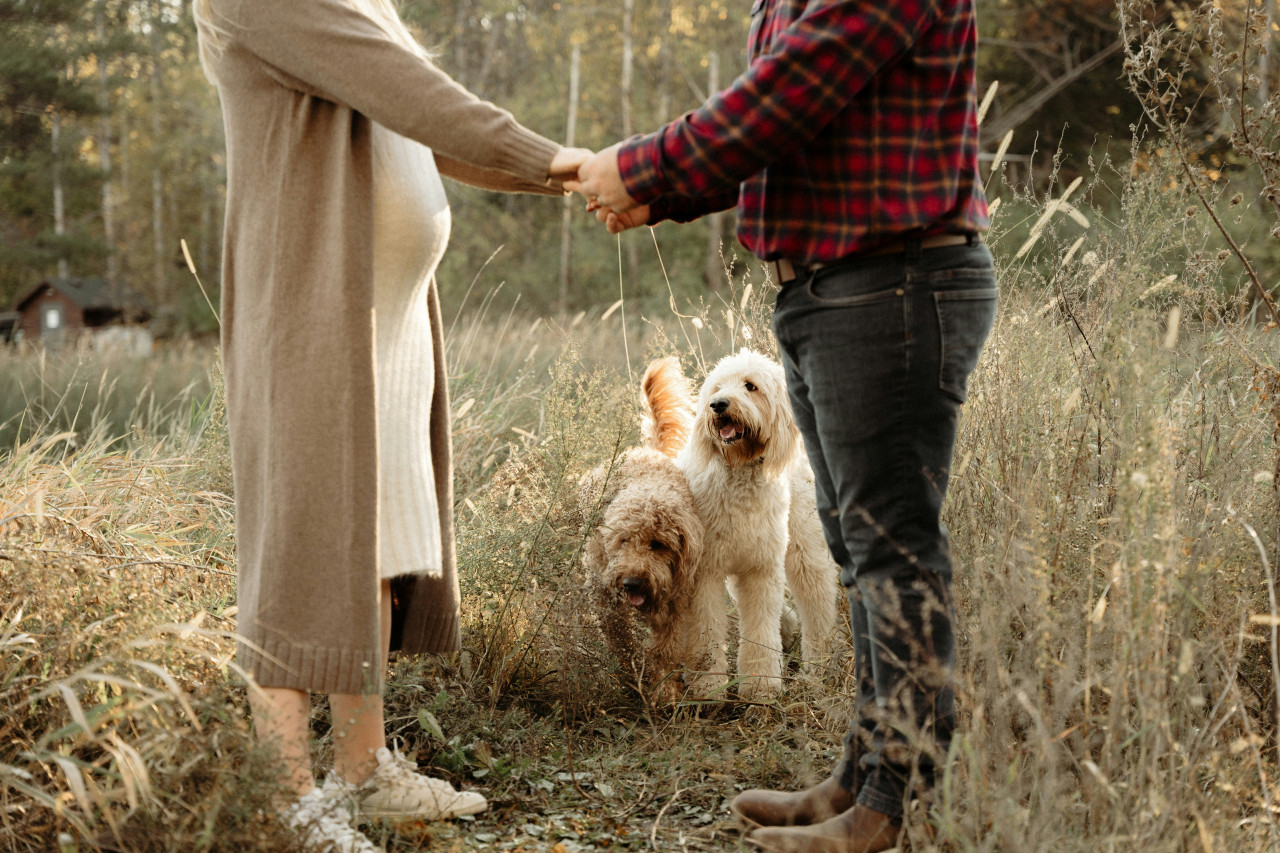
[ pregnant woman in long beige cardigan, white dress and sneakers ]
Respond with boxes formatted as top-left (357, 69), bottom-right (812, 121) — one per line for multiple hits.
top-left (195, 0), bottom-right (590, 850)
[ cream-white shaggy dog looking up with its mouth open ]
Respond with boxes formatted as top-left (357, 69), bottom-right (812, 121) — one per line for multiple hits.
top-left (676, 350), bottom-right (841, 698)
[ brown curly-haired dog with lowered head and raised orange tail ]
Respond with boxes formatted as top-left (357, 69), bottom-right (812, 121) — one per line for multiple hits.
top-left (580, 359), bottom-right (703, 699)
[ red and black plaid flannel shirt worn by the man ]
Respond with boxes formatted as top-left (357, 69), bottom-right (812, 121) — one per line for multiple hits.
top-left (618, 0), bottom-right (988, 263)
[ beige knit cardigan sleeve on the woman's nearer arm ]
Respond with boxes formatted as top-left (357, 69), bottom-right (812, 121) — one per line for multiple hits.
top-left (211, 0), bottom-right (559, 186)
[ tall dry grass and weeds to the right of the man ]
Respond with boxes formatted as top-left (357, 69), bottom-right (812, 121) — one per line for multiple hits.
top-left (938, 153), bottom-right (1277, 850)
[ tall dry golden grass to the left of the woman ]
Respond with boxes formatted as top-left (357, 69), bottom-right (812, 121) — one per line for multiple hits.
top-left (0, 430), bottom-right (292, 850)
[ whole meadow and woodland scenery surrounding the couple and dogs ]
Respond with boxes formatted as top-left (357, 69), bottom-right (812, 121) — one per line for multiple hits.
top-left (0, 0), bottom-right (1280, 853)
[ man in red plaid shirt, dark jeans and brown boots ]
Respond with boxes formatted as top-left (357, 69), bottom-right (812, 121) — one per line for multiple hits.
top-left (566, 0), bottom-right (996, 853)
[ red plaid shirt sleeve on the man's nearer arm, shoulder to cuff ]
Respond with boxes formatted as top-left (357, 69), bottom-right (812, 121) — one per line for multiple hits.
top-left (620, 0), bottom-right (938, 204)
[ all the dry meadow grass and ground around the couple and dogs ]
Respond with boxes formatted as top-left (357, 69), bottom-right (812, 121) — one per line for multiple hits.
top-left (0, 147), bottom-right (1280, 853)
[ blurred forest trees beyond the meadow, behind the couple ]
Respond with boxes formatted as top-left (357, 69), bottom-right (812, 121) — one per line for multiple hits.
top-left (0, 0), bottom-right (1275, 333)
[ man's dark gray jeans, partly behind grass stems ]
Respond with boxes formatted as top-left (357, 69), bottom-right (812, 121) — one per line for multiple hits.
top-left (773, 235), bottom-right (996, 817)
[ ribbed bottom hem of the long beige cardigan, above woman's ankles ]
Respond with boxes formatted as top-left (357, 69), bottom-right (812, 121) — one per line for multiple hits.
top-left (237, 634), bottom-right (383, 695)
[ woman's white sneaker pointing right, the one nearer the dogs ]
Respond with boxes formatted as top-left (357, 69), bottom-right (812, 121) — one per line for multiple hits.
top-left (324, 747), bottom-right (489, 821)
